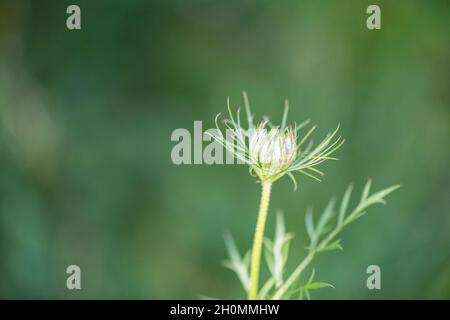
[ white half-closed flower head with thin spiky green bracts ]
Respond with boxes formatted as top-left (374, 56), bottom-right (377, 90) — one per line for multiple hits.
top-left (211, 92), bottom-right (344, 188)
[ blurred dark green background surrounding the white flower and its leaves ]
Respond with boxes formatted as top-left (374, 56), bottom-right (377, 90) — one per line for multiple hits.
top-left (0, 0), bottom-right (450, 299)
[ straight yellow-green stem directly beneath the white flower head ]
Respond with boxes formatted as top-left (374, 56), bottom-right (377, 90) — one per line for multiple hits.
top-left (248, 182), bottom-right (272, 300)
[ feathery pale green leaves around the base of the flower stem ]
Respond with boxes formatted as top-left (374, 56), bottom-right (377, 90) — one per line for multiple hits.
top-left (225, 180), bottom-right (400, 299)
